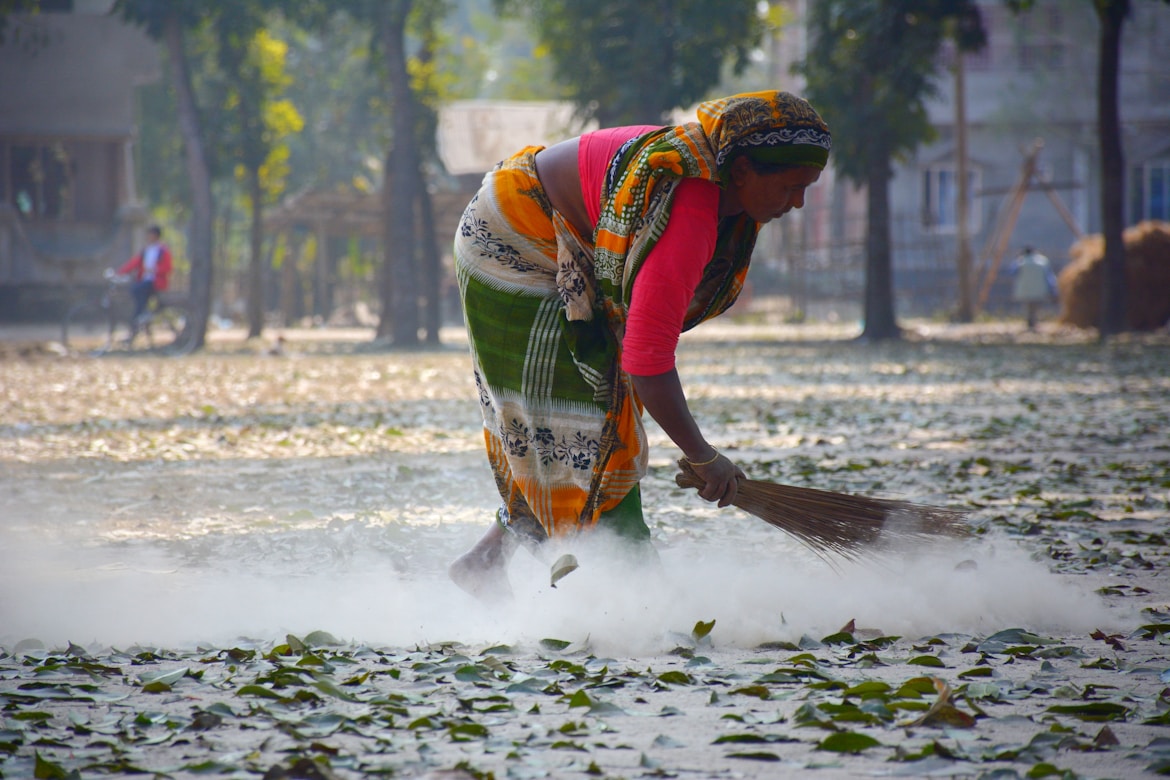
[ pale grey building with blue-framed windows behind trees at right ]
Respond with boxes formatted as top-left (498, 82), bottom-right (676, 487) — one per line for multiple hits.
top-left (763, 0), bottom-right (1170, 315)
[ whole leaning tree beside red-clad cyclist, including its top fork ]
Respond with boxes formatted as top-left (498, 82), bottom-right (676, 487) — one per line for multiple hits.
top-left (115, 0), bottom-right (214, 350)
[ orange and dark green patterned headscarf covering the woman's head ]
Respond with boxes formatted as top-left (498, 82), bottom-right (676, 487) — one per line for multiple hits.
top-left (698, 90), bottom-right (833, 174)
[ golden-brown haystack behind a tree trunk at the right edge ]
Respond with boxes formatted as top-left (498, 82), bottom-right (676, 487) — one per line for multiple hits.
top-left (1057, 222), bottom-right (1170, 331)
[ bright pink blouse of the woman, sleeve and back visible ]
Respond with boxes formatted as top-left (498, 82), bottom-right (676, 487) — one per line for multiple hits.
top-left (577, 125), bottom-right (720, 377)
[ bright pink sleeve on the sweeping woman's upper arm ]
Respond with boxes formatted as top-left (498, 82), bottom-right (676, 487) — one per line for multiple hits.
top-left (621, 179), bottom-right (720, 377)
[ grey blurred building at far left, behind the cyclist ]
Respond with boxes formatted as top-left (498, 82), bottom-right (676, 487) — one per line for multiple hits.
top-left (0, 0), bottom-right (161, 319)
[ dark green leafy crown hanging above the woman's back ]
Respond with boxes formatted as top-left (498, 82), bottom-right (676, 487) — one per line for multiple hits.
top-left (496, 0), bottom-right (763, 126)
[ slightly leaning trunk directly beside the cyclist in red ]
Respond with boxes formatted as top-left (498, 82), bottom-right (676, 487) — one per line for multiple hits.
top-left (164, 12), bottom-right (214, 351)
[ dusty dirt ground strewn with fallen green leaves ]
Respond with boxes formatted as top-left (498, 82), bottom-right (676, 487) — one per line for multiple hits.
top-left (0, 315), bottom-right (1170, 779)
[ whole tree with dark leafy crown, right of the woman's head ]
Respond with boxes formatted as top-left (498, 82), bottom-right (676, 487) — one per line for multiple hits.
top-left (799, 0), bottom-right (985, 341)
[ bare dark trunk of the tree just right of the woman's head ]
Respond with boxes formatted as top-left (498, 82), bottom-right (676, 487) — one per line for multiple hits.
top-left (861, 150), bottom-right (901, 341)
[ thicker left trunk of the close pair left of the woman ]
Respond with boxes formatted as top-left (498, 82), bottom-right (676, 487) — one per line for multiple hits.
top-left (377, 0), bottom-right (420, 346)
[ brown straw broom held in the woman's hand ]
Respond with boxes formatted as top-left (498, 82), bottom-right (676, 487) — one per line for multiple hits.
top-left (674, 458), bottom-right (969, 564)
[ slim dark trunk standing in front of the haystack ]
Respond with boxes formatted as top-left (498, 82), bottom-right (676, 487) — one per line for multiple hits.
top-left (1095, 0), bottom-right (1129, 339)
